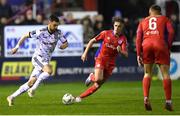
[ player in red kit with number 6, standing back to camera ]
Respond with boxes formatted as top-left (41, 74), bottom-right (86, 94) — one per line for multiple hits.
top-left (136, 5), bottom-right (174, 111)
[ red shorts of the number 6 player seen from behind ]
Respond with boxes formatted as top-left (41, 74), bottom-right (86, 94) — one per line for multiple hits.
top-left (143, 44), bottom-right (170, 65)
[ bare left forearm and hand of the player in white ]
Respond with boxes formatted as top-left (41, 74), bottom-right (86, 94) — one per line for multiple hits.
top-left (11, 33), bottom-right (30, 54)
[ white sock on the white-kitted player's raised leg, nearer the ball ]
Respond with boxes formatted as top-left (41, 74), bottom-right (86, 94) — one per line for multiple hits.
top-left (31, 72), bottom-right (50, 90)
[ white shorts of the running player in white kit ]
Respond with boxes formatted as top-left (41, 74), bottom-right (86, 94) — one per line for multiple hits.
top-left (32, 55), bottom-right (49, 70)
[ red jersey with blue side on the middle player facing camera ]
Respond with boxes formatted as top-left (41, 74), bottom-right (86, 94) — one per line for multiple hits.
top-left (95, 30), bottom-right (127, 60)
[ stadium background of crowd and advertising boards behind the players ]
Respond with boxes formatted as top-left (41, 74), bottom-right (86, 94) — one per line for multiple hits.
top-left (0, 0), bottom-right (180, 114)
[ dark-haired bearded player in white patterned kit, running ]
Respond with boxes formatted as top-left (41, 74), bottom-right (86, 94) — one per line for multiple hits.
top-left (7, 15), bottom-right (68, 106)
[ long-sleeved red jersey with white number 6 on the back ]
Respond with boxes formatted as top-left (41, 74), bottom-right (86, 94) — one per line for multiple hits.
top-left (136, 15), bottom-right (174, 56)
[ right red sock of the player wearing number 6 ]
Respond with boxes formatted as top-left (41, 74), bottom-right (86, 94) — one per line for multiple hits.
top-left (163, 78), bottom-right (172, 100)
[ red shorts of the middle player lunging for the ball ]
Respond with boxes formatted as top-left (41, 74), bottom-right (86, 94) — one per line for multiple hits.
top-left (95, 58), bottom-right (115, 77)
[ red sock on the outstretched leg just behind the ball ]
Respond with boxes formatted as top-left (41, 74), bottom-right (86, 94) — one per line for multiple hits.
top-left (80, 85), bottom-right (98, 98)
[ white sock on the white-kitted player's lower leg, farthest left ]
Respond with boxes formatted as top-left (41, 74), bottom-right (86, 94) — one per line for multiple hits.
top-left (11, 82), bottom-right (29, 98)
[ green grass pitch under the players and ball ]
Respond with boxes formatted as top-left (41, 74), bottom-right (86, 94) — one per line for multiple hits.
top-left (0, 81), bottom-right (180, 115)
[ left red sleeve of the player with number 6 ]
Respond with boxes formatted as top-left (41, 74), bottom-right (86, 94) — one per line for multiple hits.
top-left (136, 22), bottom-right (143, 56)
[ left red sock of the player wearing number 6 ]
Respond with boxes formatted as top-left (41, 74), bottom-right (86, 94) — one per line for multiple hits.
top-left (142, 77), bottom-right (151, 97)
